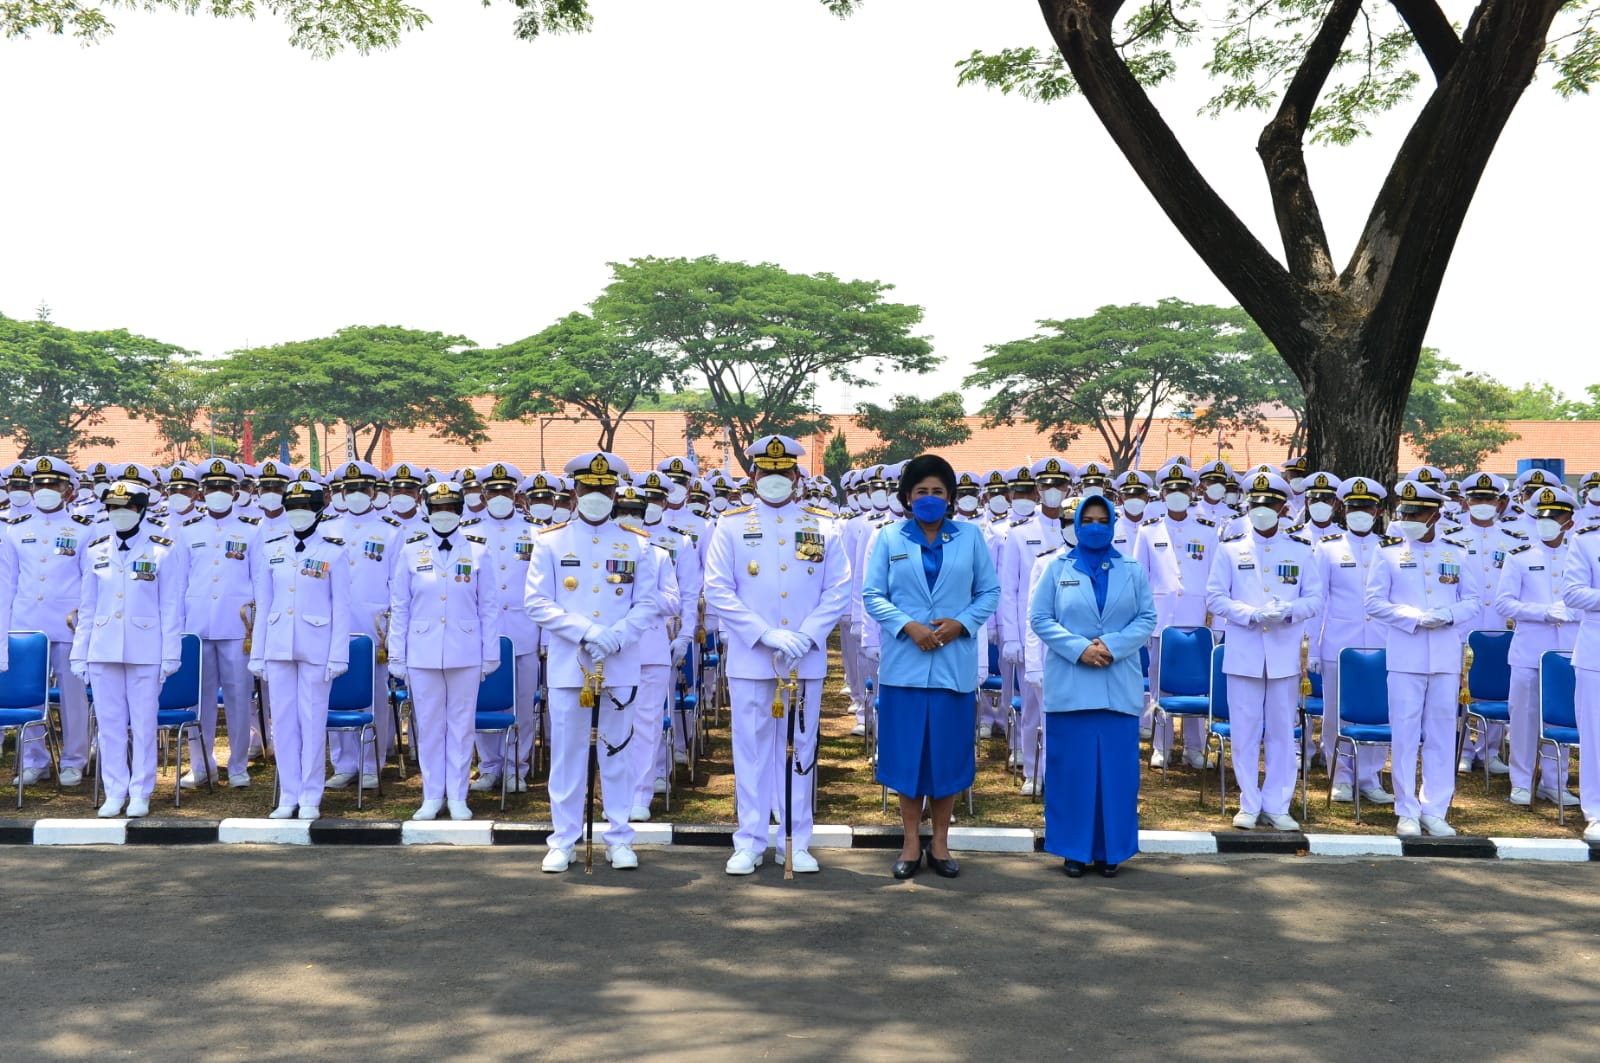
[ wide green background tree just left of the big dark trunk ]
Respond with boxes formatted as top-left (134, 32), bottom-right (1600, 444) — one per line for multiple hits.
top-left (965, 299), bottom-right (1267, 469)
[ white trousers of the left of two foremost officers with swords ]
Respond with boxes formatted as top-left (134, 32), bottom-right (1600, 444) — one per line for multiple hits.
top-left (549, 687), bottom-right (634, 848)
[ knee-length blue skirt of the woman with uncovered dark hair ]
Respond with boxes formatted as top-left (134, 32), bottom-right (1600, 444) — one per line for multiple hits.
top-left (878, 687), bottom-right (978, 797)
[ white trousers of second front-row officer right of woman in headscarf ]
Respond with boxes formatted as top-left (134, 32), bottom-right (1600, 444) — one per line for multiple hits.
top-left (1389, 672), bottom-right (1461, 820)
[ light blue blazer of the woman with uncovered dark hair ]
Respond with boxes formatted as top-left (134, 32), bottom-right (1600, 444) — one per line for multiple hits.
top-left (861, 520), bottom-right (1000, 693)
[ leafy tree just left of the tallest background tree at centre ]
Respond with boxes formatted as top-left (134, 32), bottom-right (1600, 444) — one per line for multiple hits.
top-left (482, 314), bottom-right (677, 450)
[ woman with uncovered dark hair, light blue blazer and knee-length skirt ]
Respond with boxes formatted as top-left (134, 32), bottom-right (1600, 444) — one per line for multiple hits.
top-left (861, 455), bottom-right (1000, 879)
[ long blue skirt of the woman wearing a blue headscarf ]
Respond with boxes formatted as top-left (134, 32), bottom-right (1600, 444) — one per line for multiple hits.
top-left (1045, 709), bottom-right (1139, 863)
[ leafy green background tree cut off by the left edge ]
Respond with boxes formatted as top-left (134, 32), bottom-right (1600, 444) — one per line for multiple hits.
top-left (0, 307), bottom-right (190, 459)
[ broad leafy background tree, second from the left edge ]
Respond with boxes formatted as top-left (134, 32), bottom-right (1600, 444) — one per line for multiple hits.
top-left (213, 325), bottom-right (486, 461)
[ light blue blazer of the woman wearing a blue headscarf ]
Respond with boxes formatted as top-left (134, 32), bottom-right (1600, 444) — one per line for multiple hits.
top-left (1029, 554), bottom-right (1155, 716)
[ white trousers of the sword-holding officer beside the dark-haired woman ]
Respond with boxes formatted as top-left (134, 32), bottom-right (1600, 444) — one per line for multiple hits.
top-left (728, 679), bottom-right (822, 853)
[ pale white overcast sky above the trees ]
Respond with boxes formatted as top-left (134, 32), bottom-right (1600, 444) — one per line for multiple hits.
top-left (0, 0), bottom-right (1600, 410)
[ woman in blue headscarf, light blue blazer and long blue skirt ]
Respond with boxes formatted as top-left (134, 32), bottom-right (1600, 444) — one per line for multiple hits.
top-left (1029, 495), bottom-right (1155, 879)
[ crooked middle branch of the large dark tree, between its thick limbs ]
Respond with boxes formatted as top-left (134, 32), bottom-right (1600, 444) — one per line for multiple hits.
top-left (1256, 0), bottom-right (1362, 287)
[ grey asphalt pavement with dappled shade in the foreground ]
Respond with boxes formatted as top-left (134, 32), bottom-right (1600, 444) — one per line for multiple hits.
top-left (0, 845), bottom-right (1600, 1063)
